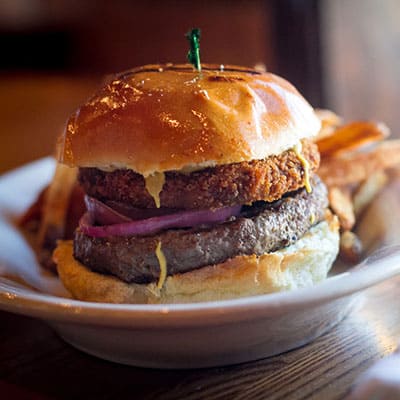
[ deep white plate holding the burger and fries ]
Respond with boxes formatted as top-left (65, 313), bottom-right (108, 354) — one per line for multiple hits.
top-left (0, 159), bottom-right (400, 368)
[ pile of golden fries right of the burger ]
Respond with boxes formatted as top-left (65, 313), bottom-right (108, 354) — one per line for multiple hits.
top-left (315, 110), bottom-right (400, 263)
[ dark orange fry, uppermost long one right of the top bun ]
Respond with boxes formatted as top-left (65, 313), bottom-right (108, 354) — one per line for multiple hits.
top-left (317, 121), bottom-right (390, 157)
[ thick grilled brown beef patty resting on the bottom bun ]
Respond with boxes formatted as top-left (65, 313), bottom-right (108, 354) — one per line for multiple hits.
top-left (74, 176), bottom-right (328, 283)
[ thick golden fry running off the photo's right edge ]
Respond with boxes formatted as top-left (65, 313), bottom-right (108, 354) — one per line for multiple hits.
top-left (318, 139), bottom-right (400, 187)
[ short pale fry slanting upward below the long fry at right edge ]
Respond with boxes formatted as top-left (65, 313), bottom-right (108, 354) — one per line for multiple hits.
top-left (353, 171), bottom-right (388, 218)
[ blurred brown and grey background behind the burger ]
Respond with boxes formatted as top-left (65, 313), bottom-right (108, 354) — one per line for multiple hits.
top-left (0, 0), bottom-right (400, 173)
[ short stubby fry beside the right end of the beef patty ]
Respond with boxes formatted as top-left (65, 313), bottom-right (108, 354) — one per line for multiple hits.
top-left (328, 187), bottom-right (356, 231)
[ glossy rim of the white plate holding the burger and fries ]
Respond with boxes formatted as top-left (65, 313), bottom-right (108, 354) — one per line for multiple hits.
top-left (0, 157), bottom-right (400, 325)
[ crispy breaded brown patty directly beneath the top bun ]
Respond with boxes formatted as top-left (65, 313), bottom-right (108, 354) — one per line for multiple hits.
top-left (79, 140), bottom-right (319, 209)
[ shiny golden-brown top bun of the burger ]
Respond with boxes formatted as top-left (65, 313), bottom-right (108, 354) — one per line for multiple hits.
top-left (58, 64), bottom-right (320, 176)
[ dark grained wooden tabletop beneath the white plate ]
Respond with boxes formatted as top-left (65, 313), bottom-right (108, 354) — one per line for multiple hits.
top-left (0, 277), bottom-right (400, 400)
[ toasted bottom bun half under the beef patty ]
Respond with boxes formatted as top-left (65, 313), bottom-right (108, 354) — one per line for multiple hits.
top-left (54, 214), bottom-right (339, 303)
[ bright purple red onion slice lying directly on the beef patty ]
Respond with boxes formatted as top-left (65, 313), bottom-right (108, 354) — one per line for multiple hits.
top-left (79, 205), bottom-right (241, 237)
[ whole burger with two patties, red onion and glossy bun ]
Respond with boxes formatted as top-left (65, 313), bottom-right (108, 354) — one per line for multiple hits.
top-left (53, 64), bottom-right (339, 303)
